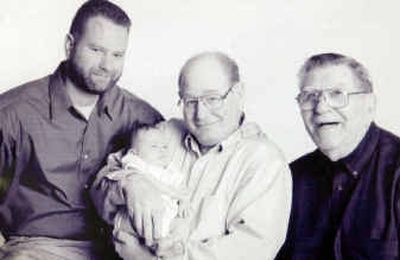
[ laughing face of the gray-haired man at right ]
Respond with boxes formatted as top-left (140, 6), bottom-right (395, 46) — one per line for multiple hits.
top-left (301, 65), bottom-right (375, 160)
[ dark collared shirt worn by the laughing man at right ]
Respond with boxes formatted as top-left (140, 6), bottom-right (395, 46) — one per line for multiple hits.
top-left (278, 123), bottom-right (400, 259)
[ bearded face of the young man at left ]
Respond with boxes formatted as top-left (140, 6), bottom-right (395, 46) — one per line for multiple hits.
top-left (68, 16), bottom-right (128, 94)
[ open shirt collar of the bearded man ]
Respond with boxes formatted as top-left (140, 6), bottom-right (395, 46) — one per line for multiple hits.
top-left (49, 61), bottom-right (118, 120)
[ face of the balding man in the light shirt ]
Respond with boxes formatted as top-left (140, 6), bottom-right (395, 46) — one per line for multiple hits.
top-left (181, 59), bottom-right (242, 148)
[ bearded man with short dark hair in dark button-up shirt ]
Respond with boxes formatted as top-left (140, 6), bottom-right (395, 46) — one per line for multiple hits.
top-left (0, 0), bottom-right (162, 260)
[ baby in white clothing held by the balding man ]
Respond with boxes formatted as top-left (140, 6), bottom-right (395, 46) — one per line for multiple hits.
top-left (107, 120), bottom-right (187, 252)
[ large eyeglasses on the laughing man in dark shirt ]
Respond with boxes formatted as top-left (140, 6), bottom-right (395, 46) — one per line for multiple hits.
top-left (296, 89), bottom-right (371, 110)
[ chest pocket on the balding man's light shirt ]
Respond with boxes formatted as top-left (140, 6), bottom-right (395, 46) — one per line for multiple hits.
top-left (191, 195), bottom-right (226, 240)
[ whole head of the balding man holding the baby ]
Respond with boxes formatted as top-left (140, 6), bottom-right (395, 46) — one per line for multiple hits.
top-left (179, 52), bottom-right (243, 151)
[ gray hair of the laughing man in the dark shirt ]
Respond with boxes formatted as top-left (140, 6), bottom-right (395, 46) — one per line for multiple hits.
top-left (298, 53), bottom-right (373, 92)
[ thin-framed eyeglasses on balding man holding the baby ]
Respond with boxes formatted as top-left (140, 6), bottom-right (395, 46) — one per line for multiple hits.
top-left (178, 84), bottom-right (236, 110)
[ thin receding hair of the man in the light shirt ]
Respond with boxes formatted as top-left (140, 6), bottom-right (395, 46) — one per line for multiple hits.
top-left (178, 52), bottom-right (240, 96)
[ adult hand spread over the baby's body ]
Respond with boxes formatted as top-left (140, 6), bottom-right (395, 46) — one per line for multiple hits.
top-left (121, 174), bottom-right (165, 247)
